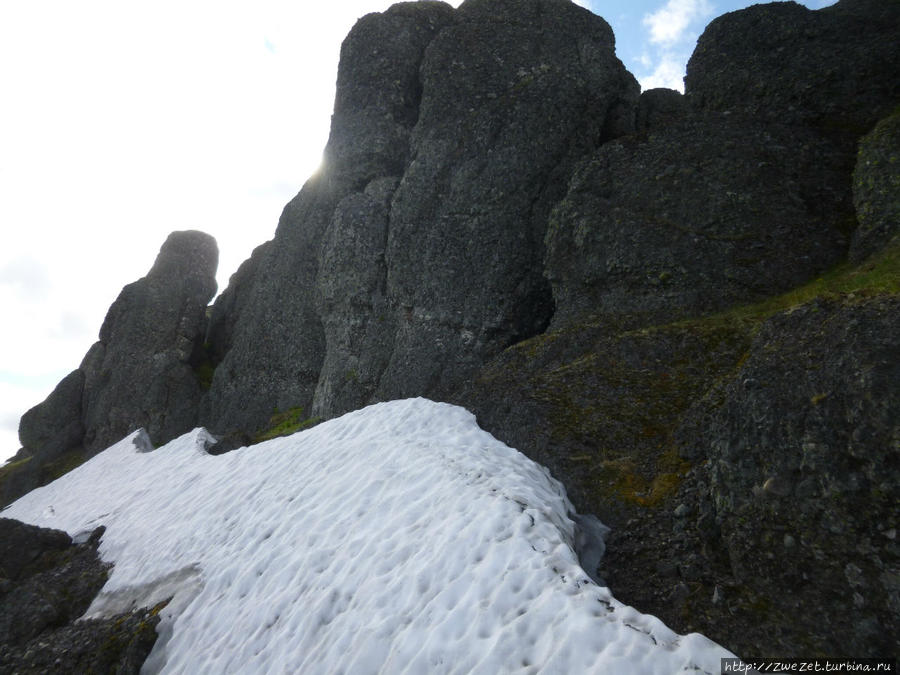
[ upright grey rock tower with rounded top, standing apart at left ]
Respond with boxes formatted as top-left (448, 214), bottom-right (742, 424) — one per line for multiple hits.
top-left (80, 231), bottom-right (218, 453)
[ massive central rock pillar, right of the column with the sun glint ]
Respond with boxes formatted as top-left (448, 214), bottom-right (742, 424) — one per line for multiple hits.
top-left (314, 0), bottom-right (638, 415)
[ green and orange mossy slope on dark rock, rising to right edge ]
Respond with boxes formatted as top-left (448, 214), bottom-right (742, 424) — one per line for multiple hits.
top-left (480, 238), bottom-right (900, 513)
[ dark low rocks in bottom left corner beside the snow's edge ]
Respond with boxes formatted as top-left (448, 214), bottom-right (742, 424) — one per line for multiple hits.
top-left (0, 518), bottom-right (159, 674)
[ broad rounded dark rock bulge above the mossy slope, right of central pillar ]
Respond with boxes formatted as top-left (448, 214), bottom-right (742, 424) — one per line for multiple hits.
top-left (546, 115), bottom-right (853, 326)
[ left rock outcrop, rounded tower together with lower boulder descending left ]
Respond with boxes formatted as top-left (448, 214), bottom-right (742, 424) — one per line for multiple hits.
top-left (3, 231), bottom-right (218, 502)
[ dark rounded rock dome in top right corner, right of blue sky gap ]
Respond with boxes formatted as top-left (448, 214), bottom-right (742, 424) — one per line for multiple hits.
top-left (685, 0), bottom-right (900, 139)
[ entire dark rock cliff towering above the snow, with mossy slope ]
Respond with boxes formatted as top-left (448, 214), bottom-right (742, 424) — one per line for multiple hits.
top-left (7, 0), bottom-right (900, 656)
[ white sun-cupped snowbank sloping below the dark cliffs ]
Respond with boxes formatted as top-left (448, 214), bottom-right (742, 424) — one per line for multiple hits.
top-left (2, 399), bottom-right (732, 675)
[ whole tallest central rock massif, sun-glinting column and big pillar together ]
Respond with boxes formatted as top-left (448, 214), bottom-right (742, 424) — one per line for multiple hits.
top-left (203, 0), bottom-right (638, 427)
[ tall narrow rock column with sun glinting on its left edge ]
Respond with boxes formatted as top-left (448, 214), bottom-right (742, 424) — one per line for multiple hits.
top-left (207, 2), bottom-right (454, 432)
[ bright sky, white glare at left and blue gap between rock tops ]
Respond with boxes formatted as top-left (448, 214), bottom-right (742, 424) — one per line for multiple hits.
top-left (0, 0), bottom-right (831, 461)
